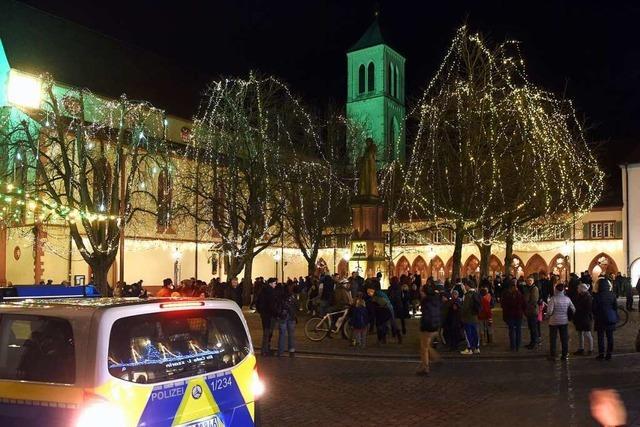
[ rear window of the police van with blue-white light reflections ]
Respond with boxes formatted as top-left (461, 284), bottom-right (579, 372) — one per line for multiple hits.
top-left (108, 309), bottom-right (250, 383)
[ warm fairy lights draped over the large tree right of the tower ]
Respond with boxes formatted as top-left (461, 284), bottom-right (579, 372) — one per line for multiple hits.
top-left (398, 27), bottom-right (603, 252)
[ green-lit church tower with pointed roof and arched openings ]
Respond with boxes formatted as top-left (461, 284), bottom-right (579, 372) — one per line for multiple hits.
top-left (347, 18), bottom-right (405, 168)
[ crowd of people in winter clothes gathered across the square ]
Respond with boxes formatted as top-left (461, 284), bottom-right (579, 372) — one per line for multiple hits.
top-left (104, 272), bottom-right (640, 374)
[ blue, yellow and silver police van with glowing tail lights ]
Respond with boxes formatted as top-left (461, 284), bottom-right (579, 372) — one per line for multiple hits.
top-left (0, 298), bottom-right (264, 427)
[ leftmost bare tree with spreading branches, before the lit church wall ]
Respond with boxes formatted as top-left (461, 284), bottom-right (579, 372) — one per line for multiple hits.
top-left (0, 76), bottom-right (168, 294)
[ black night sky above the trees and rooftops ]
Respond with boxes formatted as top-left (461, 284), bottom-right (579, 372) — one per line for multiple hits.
top-left (15, 0), bottom-right (640, 200)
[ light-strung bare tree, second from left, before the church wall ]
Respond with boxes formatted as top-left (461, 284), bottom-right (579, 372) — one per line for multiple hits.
top-left (179, 74), bottom-right (314, 291)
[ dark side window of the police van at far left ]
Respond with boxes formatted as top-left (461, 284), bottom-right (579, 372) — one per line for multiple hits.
top-left (0, 314), bottom-right (76, 384)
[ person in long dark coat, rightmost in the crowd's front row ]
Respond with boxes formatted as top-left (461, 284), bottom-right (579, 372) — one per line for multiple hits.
top-left (593, 277), bottom-right (618, 360)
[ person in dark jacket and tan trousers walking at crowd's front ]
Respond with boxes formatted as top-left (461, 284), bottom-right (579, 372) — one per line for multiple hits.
top-left (416, 286), bottom-right (442, 375)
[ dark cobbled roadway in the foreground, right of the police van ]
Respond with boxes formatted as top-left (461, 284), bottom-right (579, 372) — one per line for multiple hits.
top-left (259, 354), bottom-right (640, 427)
